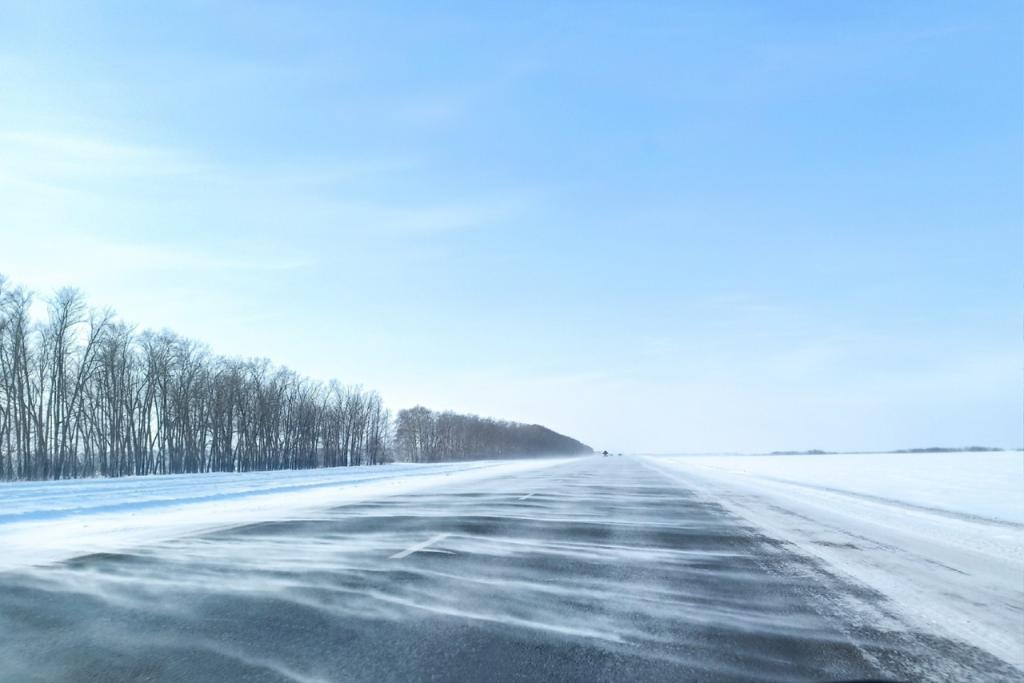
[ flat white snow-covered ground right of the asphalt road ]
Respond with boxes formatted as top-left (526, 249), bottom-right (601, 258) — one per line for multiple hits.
top-left (646, 452), bottom-right (1024, 668)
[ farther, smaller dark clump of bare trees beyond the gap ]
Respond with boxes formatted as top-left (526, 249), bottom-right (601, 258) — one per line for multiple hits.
top-left (394, 405), bottom-right (592, 463)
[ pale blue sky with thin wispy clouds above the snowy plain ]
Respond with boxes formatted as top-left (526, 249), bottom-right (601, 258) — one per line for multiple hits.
top-left (0, 1), bottom-right (1024, 452)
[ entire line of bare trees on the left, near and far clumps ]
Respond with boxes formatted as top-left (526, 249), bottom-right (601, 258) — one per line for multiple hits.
top-left (0, 276), bottom-right (591, 480)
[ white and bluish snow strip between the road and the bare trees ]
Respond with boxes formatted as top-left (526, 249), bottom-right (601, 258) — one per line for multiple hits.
top-left (0, 459), bottom-right (565, 570)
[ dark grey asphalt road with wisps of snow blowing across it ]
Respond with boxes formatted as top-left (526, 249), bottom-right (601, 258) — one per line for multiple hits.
top-left (0, 457), bottom-right (1015, 683)
